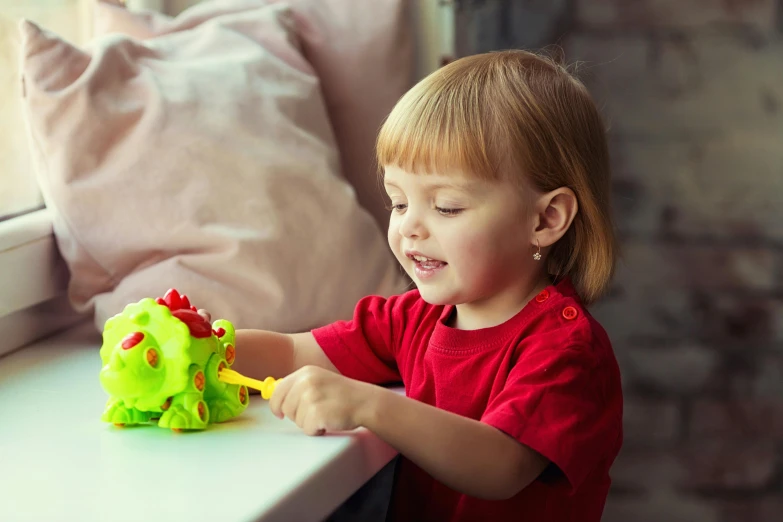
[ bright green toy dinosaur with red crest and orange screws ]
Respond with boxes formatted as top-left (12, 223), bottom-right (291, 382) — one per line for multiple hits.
top-left (100, 289), bottom-right (249, 431)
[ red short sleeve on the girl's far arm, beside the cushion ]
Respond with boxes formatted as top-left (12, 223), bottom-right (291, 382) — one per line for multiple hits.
top-left (312, 296), bottom-right (408, 384)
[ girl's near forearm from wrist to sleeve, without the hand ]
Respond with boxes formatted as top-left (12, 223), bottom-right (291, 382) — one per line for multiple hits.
top-left (357, 386), bottom-right (549, 500)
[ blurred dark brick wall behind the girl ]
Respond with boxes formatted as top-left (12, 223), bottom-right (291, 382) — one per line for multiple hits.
top-left (457, 0), bottom-right (783, 522)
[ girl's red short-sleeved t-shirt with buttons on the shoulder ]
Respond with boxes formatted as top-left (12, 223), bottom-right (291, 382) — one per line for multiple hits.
top-left (313, 280), bottom-right (622, 522)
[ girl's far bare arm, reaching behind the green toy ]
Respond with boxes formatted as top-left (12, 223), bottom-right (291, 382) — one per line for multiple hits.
top-left (232, 330), bottom-right (339, 380)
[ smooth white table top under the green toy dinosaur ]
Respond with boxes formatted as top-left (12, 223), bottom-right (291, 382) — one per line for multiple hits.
top-left (0, 324), bottom-right (402, 522)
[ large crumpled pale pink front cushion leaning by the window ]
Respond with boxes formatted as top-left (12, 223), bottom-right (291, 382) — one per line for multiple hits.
top-left (22, 2), bottom-right (404, 331)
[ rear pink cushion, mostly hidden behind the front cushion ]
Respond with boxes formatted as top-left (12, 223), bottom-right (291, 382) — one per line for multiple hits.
top-left (95, 0), bottom-right (414, 228)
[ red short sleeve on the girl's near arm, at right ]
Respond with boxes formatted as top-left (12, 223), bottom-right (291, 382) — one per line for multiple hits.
top-left (481, 347), bottom-right (622, 490)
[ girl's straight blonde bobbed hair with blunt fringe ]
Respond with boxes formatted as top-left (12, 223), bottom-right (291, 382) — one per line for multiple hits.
top-left (376, 50), bottom-right (618, 304)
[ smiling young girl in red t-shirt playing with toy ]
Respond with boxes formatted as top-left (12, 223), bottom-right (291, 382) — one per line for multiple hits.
top-left (237, 51), bottom-right (622, 522)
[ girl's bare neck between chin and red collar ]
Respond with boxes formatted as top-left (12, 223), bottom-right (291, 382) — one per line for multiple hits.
top-left (448, 274), bottom-right (551, 330)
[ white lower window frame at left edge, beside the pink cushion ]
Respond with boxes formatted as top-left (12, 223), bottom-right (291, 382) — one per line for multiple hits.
top-left (0, 209), bottom-right (84, 356)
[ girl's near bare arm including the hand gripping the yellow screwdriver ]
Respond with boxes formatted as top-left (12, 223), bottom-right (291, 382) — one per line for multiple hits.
top-left (269, 366), bottom-right (548, 499)
